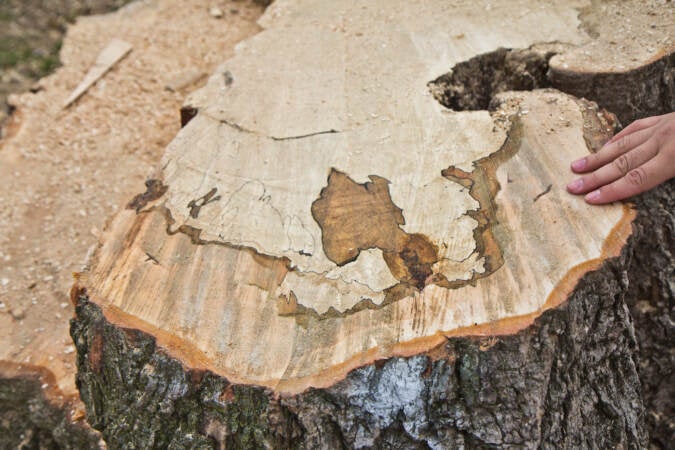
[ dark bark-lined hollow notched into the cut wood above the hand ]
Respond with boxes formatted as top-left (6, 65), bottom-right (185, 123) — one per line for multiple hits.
top-left (429, 44), bottom-right (675, 126)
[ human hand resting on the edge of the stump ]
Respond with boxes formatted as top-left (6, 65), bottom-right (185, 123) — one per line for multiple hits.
top-left (567, 112), bottom-right (675, 205)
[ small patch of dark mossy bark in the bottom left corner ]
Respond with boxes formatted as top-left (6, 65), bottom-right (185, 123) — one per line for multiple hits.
top-left (0, 374), bottom-right (100, 449)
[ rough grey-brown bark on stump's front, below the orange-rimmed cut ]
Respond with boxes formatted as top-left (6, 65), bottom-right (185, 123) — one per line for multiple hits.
top-left (71, 234), bottom-right (647, 448)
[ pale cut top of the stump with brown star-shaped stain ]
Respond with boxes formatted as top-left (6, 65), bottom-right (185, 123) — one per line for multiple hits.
top-left (82, 1), bottom-right (672, 394)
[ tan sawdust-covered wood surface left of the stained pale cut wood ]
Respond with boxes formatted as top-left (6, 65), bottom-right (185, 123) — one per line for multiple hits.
top-left (0, 0), bottom-right (262, 404)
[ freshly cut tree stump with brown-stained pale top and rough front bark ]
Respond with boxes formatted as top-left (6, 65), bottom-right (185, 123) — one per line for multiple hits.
top-left (71, 0), bottom-right (673, 448)
